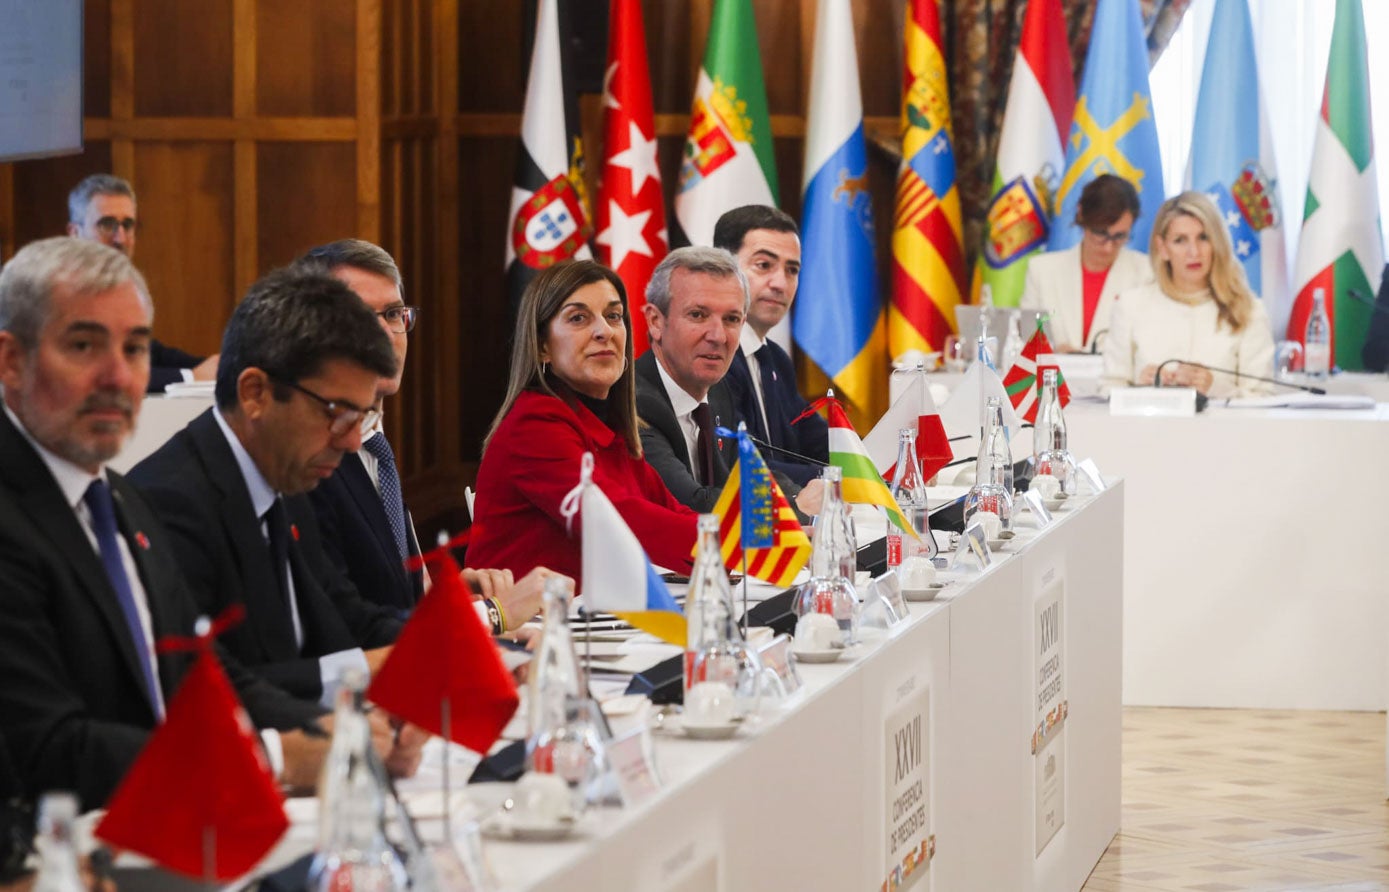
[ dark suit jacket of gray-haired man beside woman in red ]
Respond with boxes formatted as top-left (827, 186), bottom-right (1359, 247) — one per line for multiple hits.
top-left (636, 350), bottom-right (738, 511)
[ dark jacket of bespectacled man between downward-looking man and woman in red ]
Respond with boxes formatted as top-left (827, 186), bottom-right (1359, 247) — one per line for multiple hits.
top-left (308, 447), bottom-right (424, 616)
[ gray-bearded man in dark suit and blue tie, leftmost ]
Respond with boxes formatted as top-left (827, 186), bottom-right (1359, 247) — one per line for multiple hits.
top-left (0, 238), bottom-right (389, 809)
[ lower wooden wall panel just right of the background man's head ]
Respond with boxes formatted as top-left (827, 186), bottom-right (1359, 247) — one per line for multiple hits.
top-left (135, 142), bottom-right (240, 356)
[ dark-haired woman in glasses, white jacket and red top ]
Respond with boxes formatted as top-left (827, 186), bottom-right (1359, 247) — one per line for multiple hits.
top-left (1020, 174), bottom-right (1153, 353)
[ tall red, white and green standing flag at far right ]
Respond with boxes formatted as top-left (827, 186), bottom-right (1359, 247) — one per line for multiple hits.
top-left (1288, 0), bottom-right (1385, 368)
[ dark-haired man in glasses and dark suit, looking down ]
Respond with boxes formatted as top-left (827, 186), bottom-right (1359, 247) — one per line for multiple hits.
top-left (129, 271), bottom-right (400, 704)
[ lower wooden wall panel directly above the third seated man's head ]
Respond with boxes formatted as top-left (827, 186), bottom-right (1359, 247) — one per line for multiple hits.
top-left (254, 143), bottom-right (358, 270)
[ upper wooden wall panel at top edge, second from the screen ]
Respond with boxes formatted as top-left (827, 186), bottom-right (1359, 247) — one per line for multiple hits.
top-left (255, 0), bottom-right (357, 118)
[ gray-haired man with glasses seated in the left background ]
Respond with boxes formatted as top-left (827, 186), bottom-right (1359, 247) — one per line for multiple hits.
top-left (68, 174), bottom-right (217, 393)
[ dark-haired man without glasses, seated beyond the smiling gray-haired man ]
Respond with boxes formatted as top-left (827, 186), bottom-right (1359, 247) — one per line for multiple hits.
top-left (714, 204), bottom-right (829, 485)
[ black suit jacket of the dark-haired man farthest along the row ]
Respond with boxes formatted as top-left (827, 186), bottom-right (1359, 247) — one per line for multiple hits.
top-left (724, 340), bottom-right (829, 486)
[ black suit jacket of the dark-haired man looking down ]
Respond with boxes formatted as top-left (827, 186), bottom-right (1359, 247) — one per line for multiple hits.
top-left (129, 408), bottom-right (400, 700)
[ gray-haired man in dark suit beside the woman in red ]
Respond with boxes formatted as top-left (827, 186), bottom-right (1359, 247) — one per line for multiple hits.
top-left (636, 247), bottom-right (821, 514)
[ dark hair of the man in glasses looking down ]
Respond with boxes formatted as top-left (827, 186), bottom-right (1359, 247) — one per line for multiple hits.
top-left (215, 270), bottom-right (396, 410)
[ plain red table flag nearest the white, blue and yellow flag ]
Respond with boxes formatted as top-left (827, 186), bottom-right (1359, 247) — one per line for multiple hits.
top-left (367, 538), bottom-right (519, 753)
